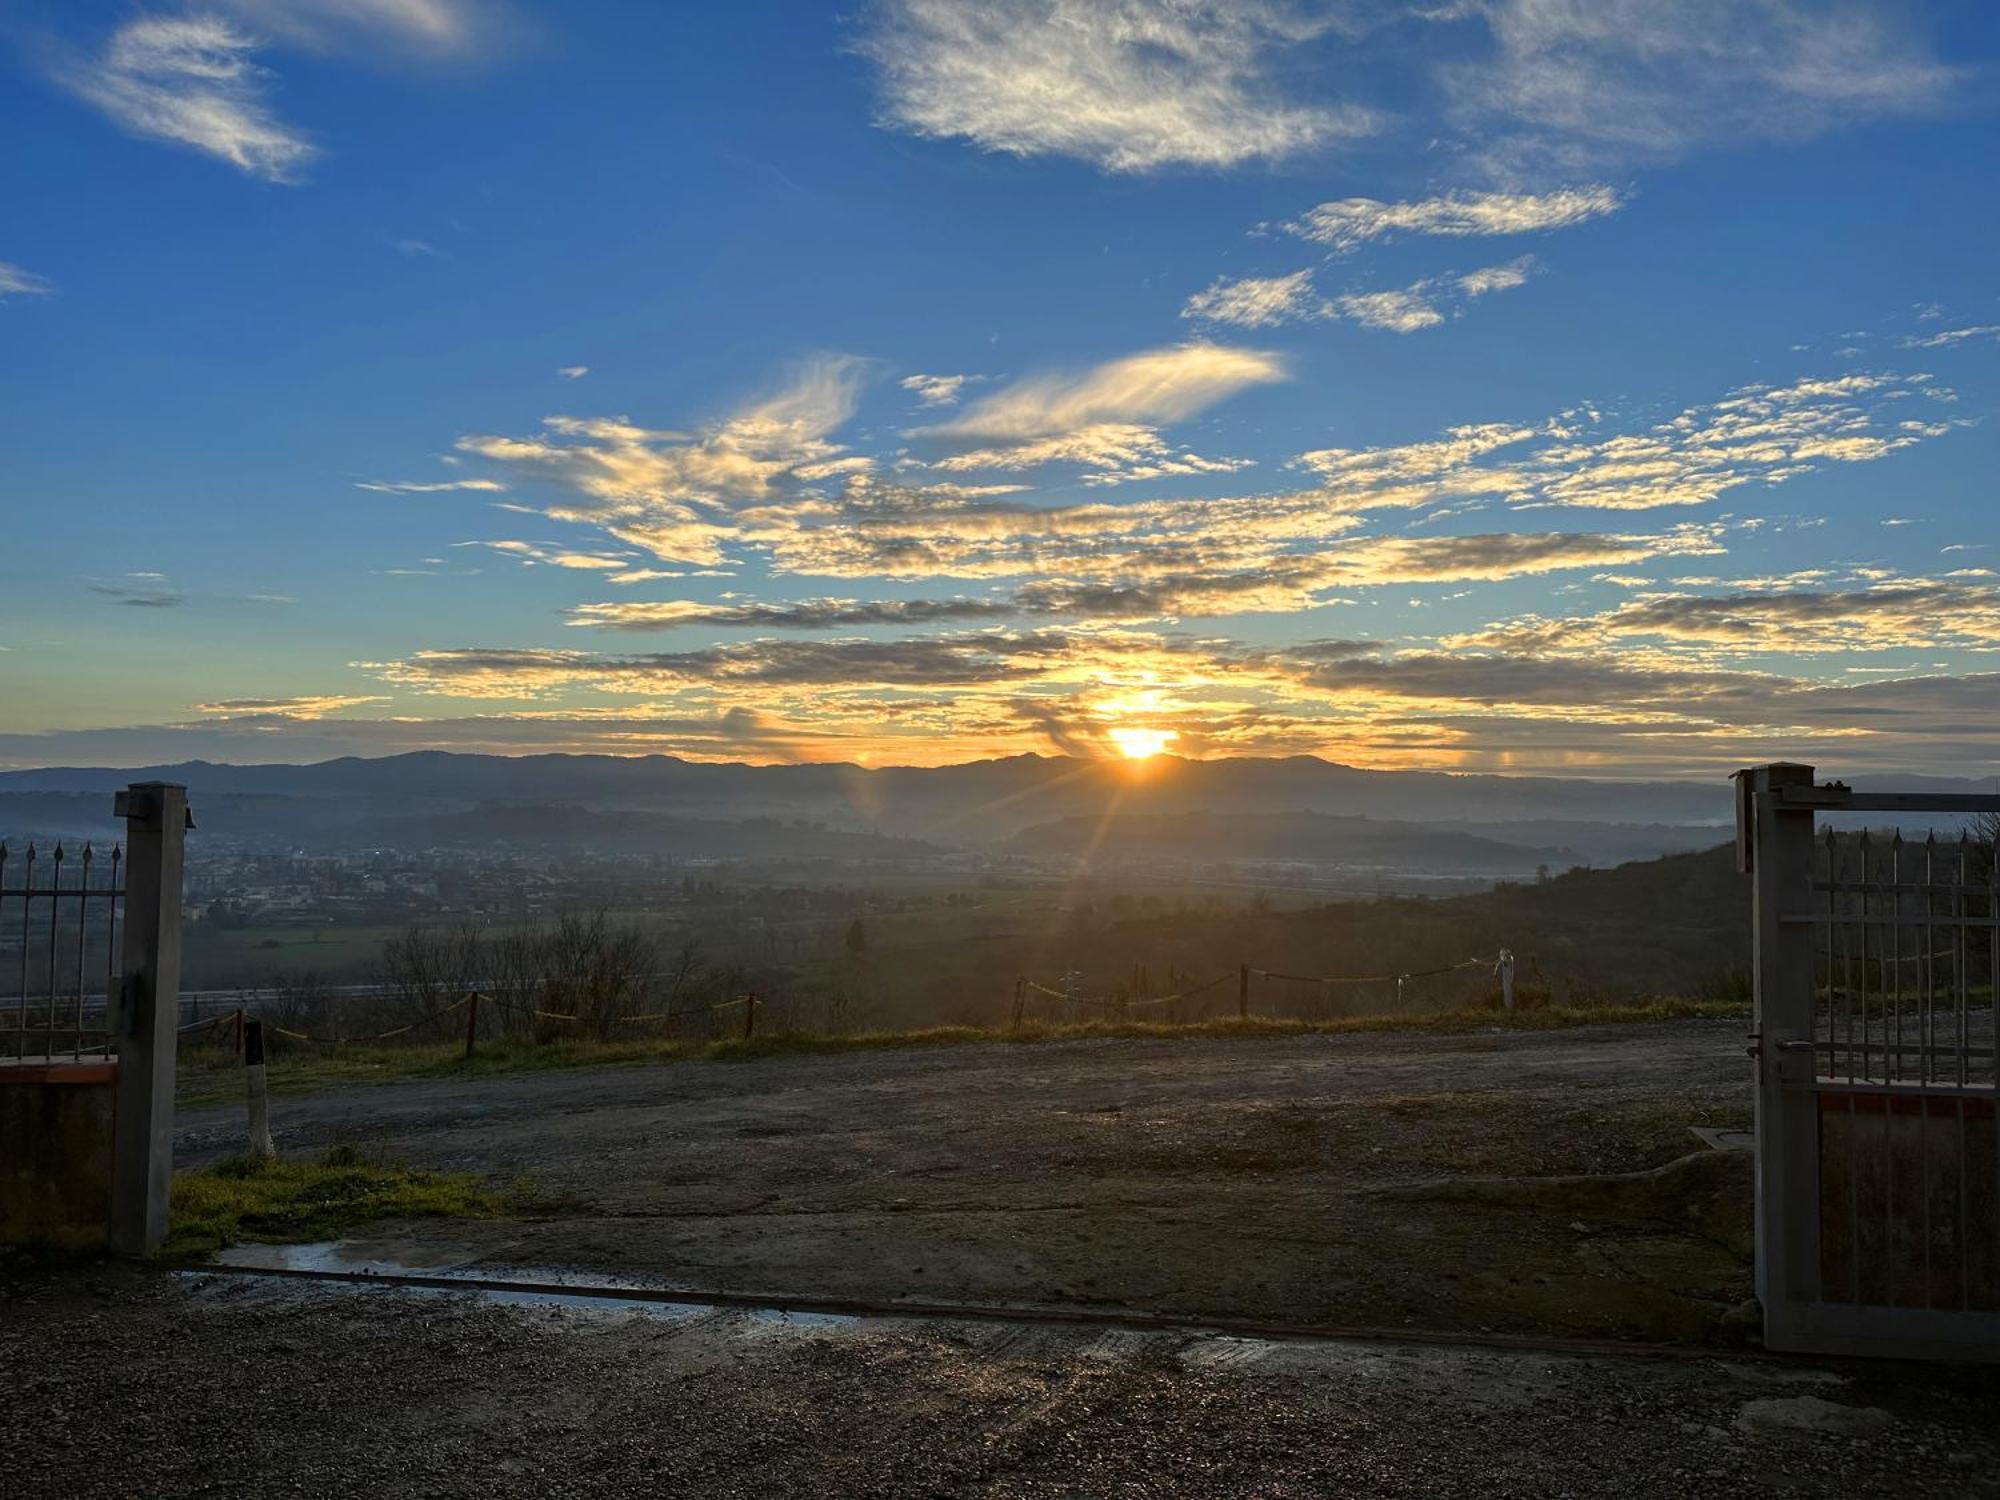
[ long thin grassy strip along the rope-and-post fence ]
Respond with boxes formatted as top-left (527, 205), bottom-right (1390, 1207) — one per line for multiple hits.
top-left (180, 1000), bottom-right (1748, 1108)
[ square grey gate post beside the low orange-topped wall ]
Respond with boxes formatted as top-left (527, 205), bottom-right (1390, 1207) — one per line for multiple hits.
top-left (110, 782), bottom-right (192, 1256)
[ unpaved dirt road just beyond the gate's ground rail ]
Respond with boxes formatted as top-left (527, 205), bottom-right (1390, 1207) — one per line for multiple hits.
top-left (180, 1022), bottom-right (1748, 1340)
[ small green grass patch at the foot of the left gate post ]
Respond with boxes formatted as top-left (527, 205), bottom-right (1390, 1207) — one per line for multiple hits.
top-left (166, 1146), bottom-right (506, 1256)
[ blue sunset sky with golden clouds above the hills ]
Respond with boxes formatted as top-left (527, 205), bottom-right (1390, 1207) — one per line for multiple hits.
top-left (0, 0), bottom-right (2000, 778)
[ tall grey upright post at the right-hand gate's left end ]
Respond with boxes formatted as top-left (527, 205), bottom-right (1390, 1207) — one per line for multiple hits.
top-left (1736, 764), bottom-right (1820, 1348)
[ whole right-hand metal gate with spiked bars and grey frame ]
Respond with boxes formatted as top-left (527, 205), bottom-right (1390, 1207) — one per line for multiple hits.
top-left (1736, 764), bottom-right (2000, 1360)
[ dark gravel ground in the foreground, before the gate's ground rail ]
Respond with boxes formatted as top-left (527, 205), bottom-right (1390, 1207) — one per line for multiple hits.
top-left (0, 1270), bottom-right (2000, 1500)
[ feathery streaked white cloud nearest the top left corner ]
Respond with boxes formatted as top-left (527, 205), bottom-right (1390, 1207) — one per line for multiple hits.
top-left (60, 16), bottom-right (318, 182)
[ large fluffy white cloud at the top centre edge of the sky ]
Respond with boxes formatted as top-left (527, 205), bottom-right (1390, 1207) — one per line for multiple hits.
top-left (860, 0), bottom-right (1378, 172)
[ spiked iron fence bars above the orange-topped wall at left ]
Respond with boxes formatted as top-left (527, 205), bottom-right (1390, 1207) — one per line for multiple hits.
top-left (0, 840), bottom-right (126, 1062)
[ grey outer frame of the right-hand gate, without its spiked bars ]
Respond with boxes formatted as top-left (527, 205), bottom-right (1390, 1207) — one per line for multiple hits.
top-left (1734, 762), bottom-right (2000, 1360)
